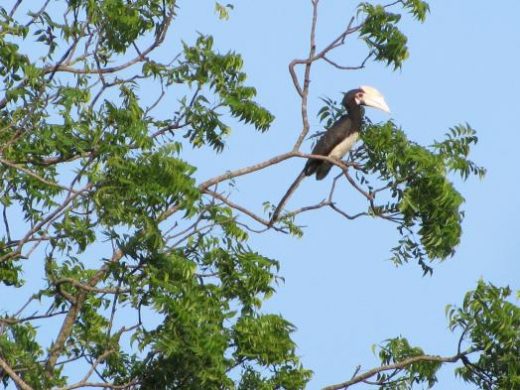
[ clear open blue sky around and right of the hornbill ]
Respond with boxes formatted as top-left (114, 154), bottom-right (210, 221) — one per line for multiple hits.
top-left (174, 0), bottom-right (520, 389)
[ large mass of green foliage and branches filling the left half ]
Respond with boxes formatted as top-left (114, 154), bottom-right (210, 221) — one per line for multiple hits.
top-left (0, 0), bottom-right (310, 389)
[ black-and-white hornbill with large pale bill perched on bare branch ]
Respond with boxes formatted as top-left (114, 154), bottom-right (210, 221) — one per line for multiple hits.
top-left (269, 86), bottom-right (390, 226)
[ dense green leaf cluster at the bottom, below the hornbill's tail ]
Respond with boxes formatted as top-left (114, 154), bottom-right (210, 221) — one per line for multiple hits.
top-left (116, 212), bottom-right (309, 389)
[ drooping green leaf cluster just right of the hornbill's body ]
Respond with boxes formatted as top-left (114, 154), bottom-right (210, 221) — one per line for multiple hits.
top-left (356, 121), bottom-right (484, 271)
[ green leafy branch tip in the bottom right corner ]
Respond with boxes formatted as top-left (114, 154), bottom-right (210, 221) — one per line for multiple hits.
top-left (358, 281), bottom-right (520, 390)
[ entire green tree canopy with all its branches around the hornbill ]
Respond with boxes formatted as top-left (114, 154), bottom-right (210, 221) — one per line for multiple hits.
top-left (0, 0), bottom-right (520, 389)
